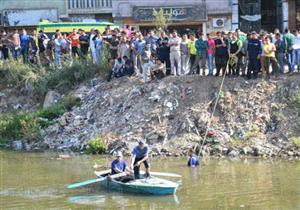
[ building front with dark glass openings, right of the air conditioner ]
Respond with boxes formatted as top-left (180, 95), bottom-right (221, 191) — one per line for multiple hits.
top-left (232, 0), bottom-right (300, 32)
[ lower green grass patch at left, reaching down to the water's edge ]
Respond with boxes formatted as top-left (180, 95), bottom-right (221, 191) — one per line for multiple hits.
top-left (0, 96), bottom-right (80, 144)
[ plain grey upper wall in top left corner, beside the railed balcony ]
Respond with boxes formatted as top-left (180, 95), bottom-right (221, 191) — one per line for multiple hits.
top-left (0, 0), bottom-right (66, 15)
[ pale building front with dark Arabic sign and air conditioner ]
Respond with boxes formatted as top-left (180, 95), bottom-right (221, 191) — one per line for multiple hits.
top-left (113, 0), bottom-right (231, 33)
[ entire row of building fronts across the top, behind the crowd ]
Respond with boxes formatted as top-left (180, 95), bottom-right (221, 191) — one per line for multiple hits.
top-left (0, 0), bottom-right (300, 33)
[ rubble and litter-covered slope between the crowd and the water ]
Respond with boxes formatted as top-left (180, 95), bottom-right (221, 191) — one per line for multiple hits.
top-left (44, 76), bottom-right (300, 156)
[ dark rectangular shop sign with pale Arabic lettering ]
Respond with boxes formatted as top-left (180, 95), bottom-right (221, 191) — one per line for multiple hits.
top-left (133, 4), bottom-right (207, 21)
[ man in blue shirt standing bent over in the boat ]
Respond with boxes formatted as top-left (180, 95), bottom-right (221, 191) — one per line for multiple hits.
top-left (131, 140), bottom-right (150, 179)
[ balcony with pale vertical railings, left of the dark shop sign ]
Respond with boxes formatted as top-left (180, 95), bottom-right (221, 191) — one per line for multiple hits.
top-left (67, 0), bottom-right (112, 14)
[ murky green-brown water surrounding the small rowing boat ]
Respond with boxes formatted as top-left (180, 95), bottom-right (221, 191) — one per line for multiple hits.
top-left (0, 151), bottom-right (300, 210)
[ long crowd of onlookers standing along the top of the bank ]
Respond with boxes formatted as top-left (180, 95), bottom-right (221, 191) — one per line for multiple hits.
top-left (0, 26), bottom-right (300, 82)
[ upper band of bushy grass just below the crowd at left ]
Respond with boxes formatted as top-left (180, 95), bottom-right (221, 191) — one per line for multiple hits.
top-left (0, 47), bottom-right (109, 96)
